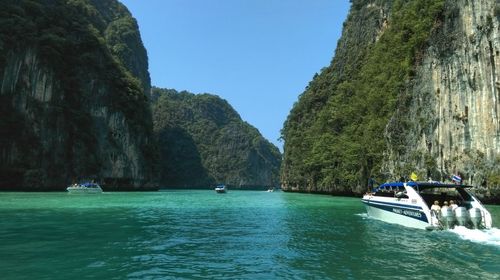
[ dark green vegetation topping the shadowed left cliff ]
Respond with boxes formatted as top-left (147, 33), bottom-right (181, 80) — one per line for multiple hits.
top-left (0, 0), bottom-right (149, 125)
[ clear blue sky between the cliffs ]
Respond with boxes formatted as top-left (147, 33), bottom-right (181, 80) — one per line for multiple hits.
top-left (120, 0), bottom-right (350, 150)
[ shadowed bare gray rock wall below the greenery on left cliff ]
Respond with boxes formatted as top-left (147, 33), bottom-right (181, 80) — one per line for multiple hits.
top-left (0, 48), bottom-right (155, 190)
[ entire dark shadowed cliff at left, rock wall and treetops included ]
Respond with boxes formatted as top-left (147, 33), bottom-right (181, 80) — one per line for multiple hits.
top-left (0, 0), bottom-right (155, 190)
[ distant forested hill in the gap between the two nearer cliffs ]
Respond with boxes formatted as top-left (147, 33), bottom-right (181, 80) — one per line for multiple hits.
top-left (153, 88), bottom-right (281, 188)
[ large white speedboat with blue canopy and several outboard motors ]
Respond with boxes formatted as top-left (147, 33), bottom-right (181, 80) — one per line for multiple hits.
top-left (362, 182), bottom-right (492, 230)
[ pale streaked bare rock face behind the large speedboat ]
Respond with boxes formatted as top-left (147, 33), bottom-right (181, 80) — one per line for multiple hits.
top-left (384, 0), bottom-right (500, 200)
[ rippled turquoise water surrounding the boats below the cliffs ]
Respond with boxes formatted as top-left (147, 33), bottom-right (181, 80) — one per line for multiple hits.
top-left (0, 190), bottom-right (500, 280)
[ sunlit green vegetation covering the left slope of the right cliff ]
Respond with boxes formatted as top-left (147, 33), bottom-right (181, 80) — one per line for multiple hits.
top-left (281, 0), bottom-right (444, 193)
